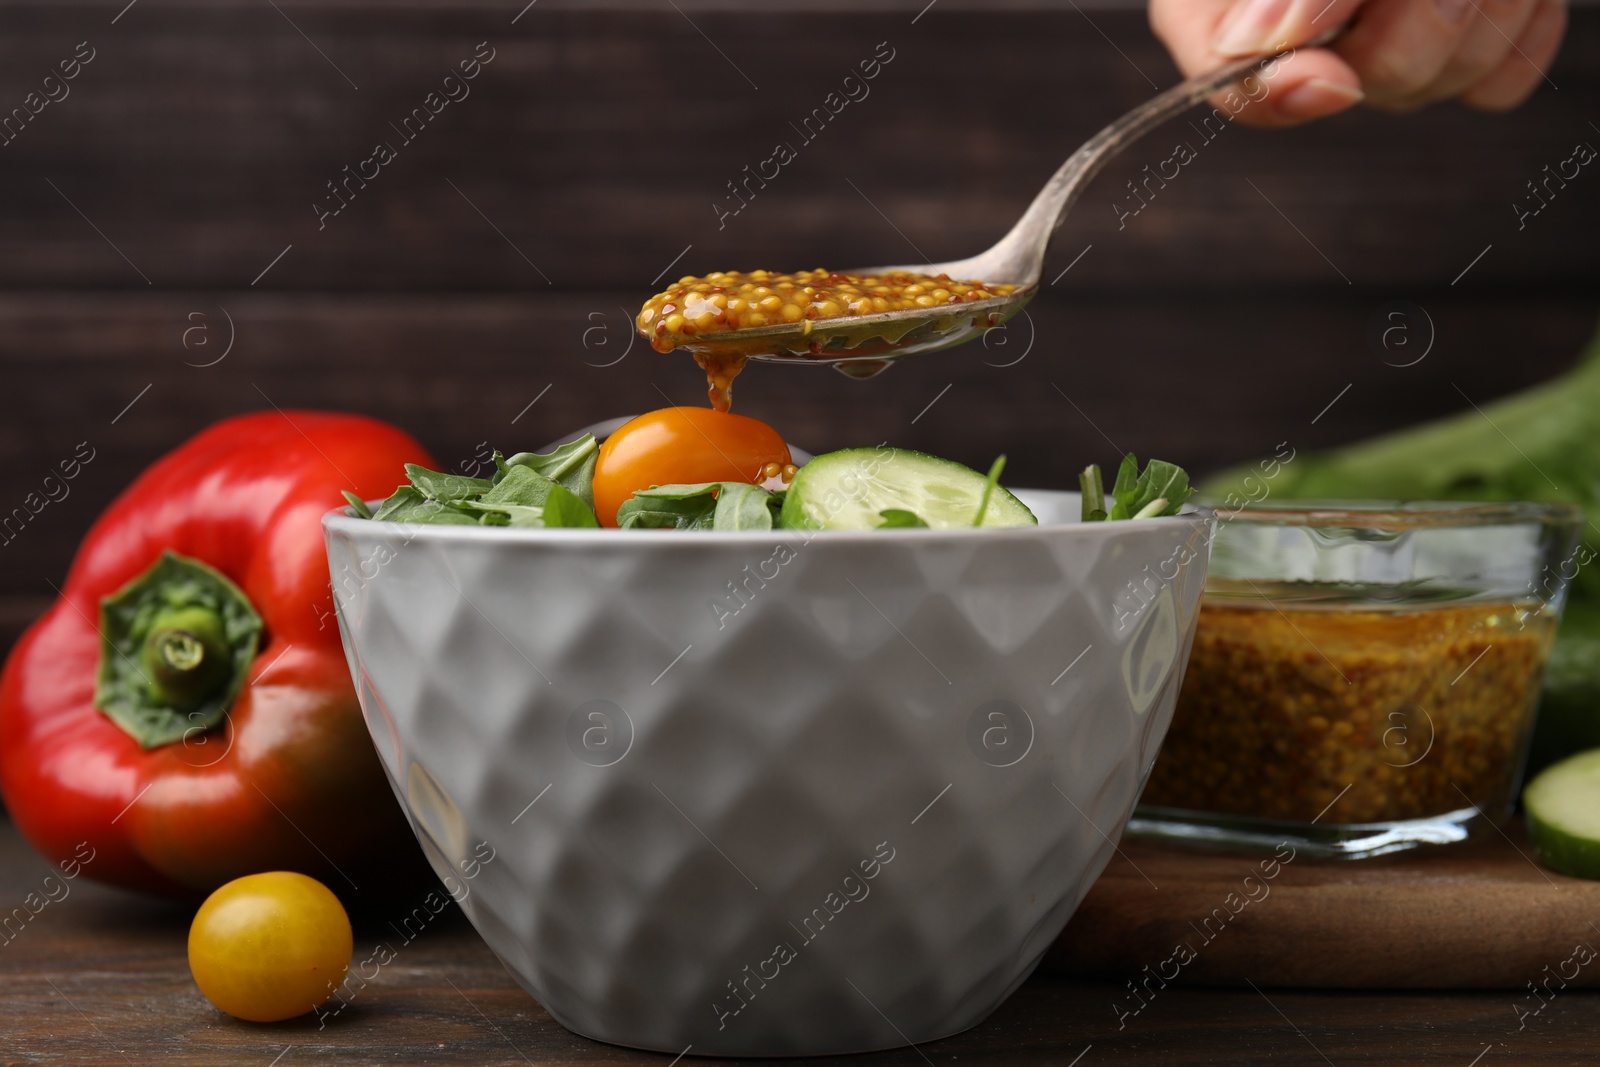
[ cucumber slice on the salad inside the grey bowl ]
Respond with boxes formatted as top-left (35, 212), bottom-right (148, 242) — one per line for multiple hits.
top-left (782, 448), bottom-right (1038, 530)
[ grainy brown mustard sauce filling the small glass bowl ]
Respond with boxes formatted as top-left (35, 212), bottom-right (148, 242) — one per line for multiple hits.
top-left (1141, 601), bottom-right (1555, 824)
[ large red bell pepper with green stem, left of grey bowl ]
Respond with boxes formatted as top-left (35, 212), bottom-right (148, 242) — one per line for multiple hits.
top-left (0, 411), bottom-right (434, 896)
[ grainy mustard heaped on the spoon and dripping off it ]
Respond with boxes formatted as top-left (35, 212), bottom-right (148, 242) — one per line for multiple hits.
top-left (637, 270), bottom-right (1016, 411)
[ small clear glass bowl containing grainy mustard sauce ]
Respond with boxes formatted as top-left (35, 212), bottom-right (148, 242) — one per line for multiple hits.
top-left (1128, 501), bottom-right (1582, 857)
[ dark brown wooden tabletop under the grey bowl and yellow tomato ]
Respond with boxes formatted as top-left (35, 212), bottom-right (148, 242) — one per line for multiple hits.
top-left (0, 822), bottom-right (1600, 1067)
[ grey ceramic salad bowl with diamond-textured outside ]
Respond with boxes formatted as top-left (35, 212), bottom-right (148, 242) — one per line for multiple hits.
top-left (323, 491), bottom-right (1213, 1056)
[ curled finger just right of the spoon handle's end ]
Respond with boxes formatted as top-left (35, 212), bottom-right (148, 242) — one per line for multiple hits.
top-left (1333, 0), bottom-right (1474, 107)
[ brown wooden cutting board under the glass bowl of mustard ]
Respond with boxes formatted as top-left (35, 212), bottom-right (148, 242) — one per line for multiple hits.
top-left (1045, 822), bottom-right (1600, 991)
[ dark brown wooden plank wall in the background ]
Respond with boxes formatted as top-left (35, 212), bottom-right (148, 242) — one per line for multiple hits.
top-left (0, 0), bottom-right (1600, 646)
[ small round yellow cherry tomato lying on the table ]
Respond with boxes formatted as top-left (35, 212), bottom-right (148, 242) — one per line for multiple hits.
top-left (189, 870), bottom-right (352, 1022)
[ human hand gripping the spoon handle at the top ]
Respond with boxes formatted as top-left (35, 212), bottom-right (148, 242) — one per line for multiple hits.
top-left (1150, 0), bottom-right (1566, 126)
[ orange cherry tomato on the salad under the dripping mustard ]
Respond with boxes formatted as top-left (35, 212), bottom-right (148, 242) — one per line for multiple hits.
top-left (594, 408), bottom-right (789, 526)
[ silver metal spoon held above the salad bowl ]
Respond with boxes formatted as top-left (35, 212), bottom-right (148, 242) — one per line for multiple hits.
top-left (656, 26), bottom-right (1344, 378)
